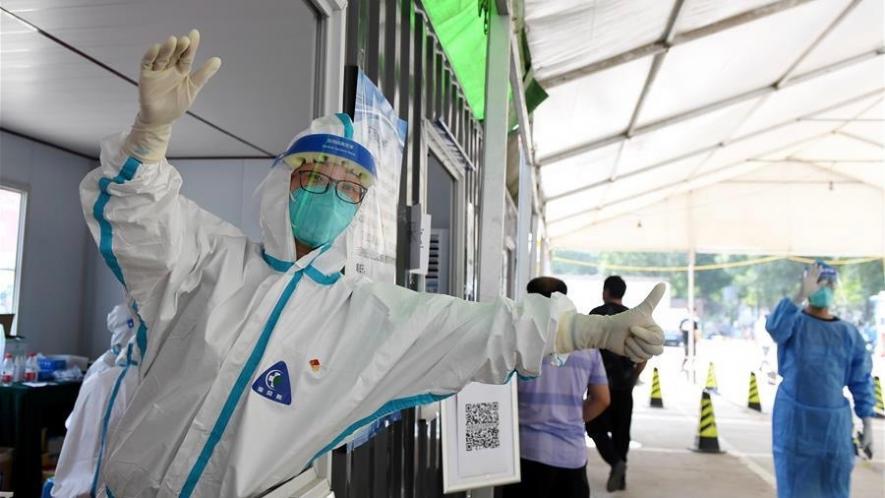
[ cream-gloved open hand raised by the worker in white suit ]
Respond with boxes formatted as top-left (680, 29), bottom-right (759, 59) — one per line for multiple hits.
top-left (123, 30), bottom-right (221, 162)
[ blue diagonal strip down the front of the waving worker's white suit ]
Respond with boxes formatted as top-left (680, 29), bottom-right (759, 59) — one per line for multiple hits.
top-left (179, 271), bottom-right (304, 498)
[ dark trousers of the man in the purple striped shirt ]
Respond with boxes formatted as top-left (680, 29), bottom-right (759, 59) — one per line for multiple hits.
top-left (502, 458), bottom-right (590, 498)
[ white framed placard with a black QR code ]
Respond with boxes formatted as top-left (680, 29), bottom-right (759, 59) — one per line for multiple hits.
top-left (442, 381), bottom-right (519, 493)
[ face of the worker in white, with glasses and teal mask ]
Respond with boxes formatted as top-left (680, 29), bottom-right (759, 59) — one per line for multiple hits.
top-left (289, 171), bottom-right (366, 248)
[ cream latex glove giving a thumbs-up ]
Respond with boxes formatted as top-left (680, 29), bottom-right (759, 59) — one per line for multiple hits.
top-left (555, 283), bottom-right (667, 363)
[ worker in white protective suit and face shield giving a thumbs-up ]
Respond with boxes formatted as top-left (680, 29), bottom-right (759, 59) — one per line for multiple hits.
top-left (80, 31), bottom-right (664, 497)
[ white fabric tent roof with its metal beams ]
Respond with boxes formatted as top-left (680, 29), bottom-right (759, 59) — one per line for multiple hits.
top-left (525, 0), bottom-right (885, 256)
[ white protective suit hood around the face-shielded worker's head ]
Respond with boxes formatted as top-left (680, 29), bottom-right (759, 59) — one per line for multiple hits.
top-left (256, 114), bottom-right (372, 273)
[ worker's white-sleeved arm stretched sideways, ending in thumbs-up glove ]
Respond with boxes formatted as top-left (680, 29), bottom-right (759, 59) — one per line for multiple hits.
top-left (353, 283), bottom-right (663, 399)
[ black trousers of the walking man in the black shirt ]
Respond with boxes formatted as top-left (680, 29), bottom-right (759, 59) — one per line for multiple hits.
top-left (586, 389), bottom-right (633, 465)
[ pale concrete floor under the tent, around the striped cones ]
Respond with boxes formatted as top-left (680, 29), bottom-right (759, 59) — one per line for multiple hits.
top-left (587, 341), bottom-right (885, 498)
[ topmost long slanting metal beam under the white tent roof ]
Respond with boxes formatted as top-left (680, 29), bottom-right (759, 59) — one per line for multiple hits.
top-left (540, 0), bottom-right (812, 90)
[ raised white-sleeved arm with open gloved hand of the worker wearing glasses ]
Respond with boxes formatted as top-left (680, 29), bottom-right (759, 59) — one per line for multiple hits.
top-left (80, 31), bottom-right (241, 358)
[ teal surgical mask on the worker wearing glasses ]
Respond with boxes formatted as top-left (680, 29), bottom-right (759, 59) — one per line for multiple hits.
top-left (289, 188), bottom-right (359, 247)
